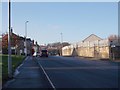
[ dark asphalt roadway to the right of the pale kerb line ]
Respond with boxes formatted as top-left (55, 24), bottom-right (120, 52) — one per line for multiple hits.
top-left (36, 56), bottom-right (118, 88)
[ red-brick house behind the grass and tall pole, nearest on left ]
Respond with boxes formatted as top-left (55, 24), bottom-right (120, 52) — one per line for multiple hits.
top-left (2, 30), bottom-right (32, 55)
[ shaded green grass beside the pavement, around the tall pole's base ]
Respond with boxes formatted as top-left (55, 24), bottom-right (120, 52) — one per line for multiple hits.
top-left (0, 55), bottom-right (24, 84)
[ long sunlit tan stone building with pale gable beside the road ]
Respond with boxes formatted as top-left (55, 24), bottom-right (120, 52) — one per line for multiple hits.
top-left (62, 34), bottom-right (113, 58)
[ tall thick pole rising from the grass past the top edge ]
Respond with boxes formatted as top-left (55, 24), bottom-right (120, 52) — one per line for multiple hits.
top-left (8, 0), bottom-right (12, 78)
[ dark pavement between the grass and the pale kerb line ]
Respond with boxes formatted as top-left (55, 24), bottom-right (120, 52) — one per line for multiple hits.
top-left (3, 56), bottom-right (51, 89)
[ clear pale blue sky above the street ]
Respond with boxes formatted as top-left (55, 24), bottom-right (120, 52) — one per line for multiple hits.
top-left (2, 2), bottom-right (118, 44)
